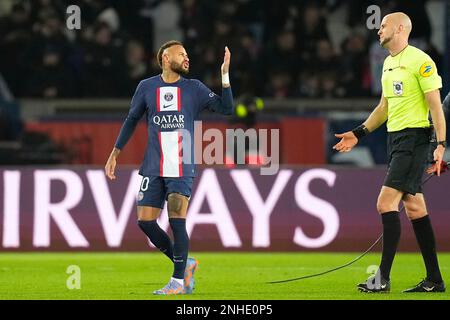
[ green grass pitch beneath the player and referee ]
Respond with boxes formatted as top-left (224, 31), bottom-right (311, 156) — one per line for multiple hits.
top-left (0, 252), bottom-right (450, 300)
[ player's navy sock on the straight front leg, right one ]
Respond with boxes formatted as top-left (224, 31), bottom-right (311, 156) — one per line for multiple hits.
top-left (169, 218), bottom-right (189, 279)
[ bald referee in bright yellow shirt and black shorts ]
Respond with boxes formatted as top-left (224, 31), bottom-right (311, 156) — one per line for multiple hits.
top-left (333, 12), bottom-right (446, 292)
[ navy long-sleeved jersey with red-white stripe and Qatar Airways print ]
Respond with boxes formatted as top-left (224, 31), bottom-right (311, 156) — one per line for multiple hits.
top-left (115, 75), bottom-right (233, 177)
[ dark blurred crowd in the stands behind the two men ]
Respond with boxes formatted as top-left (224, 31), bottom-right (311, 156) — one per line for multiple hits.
top-left (0, 0), bottom-right (441, 98)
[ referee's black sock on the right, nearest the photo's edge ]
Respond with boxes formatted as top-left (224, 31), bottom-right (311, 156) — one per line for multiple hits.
top-left (411, 215), bottom-right (442, 283)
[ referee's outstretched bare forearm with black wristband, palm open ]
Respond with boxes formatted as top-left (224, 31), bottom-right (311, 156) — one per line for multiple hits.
top-left (333, 95), bottom-right (388, 152)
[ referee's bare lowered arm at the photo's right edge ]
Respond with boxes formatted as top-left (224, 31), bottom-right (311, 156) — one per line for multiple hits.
top-left (425, 89), bottom-right (447, 176)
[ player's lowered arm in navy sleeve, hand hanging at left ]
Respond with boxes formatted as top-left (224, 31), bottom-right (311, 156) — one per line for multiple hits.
top-left (105, 82), bottom-right (145, 180)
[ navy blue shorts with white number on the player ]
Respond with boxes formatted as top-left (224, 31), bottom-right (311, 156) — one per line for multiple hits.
top-left (137, 176), bottom-right (194, 209)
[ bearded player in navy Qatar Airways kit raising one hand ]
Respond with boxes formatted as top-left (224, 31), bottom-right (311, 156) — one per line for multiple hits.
top-left (105, 41), bottom-right (233, 295)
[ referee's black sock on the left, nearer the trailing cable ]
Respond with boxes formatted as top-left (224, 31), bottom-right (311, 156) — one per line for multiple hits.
top-left (380, 211), bottom-right (401, 281)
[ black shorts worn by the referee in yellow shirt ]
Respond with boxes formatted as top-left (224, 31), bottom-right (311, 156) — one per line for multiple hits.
top-left (383, 128), bottom-right (432, 195)
